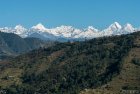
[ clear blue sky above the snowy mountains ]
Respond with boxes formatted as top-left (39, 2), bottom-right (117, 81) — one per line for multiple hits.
top-left (0, 0), bottom-right (140, 29)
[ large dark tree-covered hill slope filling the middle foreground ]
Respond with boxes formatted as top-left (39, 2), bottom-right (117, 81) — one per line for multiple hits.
top-left (0, 32), bottom-right (140, 94)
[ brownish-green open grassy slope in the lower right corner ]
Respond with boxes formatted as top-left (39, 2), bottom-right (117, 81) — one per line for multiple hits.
top-left (80, 33), bottom-right (140, 94)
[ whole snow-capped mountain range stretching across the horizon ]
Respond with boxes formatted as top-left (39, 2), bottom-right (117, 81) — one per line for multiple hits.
top-left (0, 22), bottom-right (138, 41)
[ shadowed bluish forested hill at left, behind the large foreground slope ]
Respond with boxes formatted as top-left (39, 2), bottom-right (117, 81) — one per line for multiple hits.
top-left (0, 32), bottom-right (53, 60)
